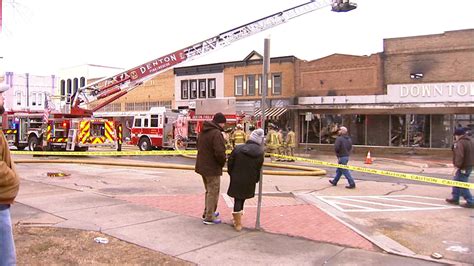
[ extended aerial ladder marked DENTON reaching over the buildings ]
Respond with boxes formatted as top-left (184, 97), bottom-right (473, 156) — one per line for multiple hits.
top-left (69, 0), bottom-right (357, 117)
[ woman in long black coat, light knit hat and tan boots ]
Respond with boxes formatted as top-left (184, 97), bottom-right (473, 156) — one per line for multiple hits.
top-left (227, 128), bottom-right (265, 231)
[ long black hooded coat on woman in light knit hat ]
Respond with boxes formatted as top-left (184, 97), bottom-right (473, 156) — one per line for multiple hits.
top-left (227, 140), bottom-right (264, 199)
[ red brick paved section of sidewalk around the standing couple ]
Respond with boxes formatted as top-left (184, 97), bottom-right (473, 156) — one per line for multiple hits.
top-left (118, 194), bottom-right (377, 251)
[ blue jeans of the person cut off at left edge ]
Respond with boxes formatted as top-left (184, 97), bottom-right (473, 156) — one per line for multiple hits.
top-left (0, 204), bottom-right (16, 266)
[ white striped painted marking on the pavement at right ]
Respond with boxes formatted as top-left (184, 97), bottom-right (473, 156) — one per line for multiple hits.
top-left (313, 195), bottom-right (460, 212)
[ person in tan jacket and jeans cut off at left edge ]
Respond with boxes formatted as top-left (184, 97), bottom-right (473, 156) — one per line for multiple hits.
top-left (0, 84), bottom-right (20, 266)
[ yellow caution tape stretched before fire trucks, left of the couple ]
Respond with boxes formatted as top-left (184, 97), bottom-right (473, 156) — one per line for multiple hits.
top-left (11, 150), bottom-right (197, 156)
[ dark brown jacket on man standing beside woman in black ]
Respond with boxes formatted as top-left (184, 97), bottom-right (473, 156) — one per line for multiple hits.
top-left (195, 121), bottom-right (226, 176)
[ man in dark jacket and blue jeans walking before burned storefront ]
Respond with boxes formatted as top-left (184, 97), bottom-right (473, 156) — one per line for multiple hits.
top-left (329, 126), bottom-right (355, 188)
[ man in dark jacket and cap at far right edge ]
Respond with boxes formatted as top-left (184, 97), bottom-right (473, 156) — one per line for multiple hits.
top-left (446, 128), bottom-right (474, 208)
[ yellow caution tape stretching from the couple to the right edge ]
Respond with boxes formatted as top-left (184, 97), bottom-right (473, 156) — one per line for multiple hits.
top-left (271, 154), bottom-right (474, 189)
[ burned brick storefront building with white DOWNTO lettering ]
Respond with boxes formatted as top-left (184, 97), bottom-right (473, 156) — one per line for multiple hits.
top-left (291, 30), bottom-right (474, 150)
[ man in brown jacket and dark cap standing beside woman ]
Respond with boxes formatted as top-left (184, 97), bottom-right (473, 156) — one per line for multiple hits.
top-left (195, 113), bottom-right (226, 224)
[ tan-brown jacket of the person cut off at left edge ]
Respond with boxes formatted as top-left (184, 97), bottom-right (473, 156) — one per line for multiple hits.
top-left (0, 130), bottom-right (20, 204)
